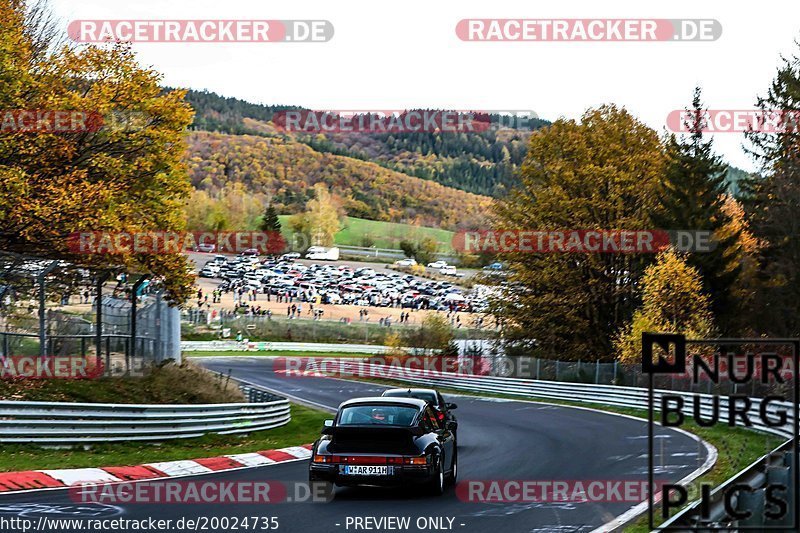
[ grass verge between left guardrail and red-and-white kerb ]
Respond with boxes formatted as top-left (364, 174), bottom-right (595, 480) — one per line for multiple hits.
top-left (0, 404), bottom-right (330, 472)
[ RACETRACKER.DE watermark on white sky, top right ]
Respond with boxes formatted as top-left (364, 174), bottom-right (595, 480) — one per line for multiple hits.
top-left (456, 19), bottom-right (722, 42)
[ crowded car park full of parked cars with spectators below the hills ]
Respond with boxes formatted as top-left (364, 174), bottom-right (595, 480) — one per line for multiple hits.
top-left (190, 253), bottom-right (488, 327)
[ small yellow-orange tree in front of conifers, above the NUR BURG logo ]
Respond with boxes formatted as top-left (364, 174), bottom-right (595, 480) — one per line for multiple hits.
top-left (615, 249), bottom-right (714, 364)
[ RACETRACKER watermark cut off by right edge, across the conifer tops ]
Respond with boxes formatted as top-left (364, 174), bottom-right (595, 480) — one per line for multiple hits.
top-left (667, 109), bottom-right (800, 133)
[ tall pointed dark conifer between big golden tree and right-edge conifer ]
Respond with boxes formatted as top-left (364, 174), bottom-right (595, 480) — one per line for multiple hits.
top-left (655, 88), bottom-right (741, 332)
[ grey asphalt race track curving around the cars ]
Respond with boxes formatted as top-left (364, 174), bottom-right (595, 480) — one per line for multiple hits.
top-left (0, 357), bottom-right (706, 533)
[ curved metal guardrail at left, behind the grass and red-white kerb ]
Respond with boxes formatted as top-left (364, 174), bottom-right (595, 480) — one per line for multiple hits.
top-left (0, 387), bottom-right (291, 445)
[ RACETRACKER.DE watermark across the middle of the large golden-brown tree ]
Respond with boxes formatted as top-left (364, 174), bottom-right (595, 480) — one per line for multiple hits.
top-left (452, 230), bottom-right (715, 254)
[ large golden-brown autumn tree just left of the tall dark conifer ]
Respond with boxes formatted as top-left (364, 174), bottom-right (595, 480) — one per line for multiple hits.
top-left (491, 105), bottom-right (666, 359)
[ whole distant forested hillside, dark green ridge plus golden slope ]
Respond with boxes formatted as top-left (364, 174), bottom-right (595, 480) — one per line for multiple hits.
top-left (180, 91), bottom-right (746, 229)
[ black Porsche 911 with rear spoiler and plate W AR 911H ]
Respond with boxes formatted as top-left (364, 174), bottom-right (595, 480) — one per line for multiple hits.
top-left (309, 397), bottom-right (458, 494)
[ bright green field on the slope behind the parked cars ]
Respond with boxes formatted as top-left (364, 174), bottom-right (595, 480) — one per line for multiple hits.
top-left (278, 215), bottom-right (453, 253)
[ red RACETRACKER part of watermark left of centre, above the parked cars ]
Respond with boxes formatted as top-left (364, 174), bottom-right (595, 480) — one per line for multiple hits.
top-left (67, 231), bottom-right (286, 255)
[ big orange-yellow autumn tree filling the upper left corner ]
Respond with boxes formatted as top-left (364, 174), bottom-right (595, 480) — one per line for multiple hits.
top-left (0, 0), bottom-right (193, 302)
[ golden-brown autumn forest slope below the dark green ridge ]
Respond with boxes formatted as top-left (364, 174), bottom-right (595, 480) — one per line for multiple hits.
top-left (187, 132), bottom-right (491, 229)
